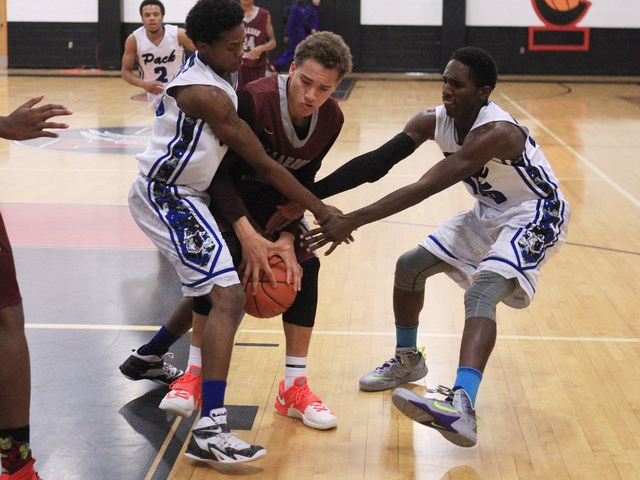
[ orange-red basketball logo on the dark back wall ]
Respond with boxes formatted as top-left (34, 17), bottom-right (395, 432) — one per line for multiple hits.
top-left (529, 0), bottom-right (591, 51)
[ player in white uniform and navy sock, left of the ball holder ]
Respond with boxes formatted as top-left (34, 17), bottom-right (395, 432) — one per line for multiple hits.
top-left (129, 0), bottom-right (337, 464)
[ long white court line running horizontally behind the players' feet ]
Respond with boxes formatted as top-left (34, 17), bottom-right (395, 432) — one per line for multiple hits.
top-left (25, 323), bottom-right (640, 343)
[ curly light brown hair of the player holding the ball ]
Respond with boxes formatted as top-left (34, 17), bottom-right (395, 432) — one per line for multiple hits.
top-left (293, 32), bottom-right (353, 80)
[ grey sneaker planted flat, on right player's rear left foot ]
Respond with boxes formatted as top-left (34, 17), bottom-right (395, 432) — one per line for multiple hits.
top-left (360, 347), bottom-right (429, 392)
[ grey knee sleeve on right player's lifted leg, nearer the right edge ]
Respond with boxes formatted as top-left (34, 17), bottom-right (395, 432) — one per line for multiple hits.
top-left (464, 271), bottom-right (517, 322)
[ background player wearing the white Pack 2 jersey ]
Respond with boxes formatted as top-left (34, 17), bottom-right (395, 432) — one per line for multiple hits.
top-left (121, 0), bottom-right (196, 110)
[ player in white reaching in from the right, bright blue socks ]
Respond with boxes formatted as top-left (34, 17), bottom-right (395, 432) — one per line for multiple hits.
top-left (308, 47), bottom-right (570, 447)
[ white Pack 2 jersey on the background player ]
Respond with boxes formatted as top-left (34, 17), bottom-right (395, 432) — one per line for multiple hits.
top-left (133, 24), bottom-right (185, 106)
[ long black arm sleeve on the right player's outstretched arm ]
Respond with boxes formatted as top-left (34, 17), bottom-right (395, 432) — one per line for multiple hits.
top-left (309, 132), bottom-right (416, 198)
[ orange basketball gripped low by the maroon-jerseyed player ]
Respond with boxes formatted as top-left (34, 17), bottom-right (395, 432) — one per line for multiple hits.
top-left (244, 256), bottom-right (297, 318)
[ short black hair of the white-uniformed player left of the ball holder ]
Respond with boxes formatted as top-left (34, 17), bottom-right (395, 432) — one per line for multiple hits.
top-left (185, 0), bottom-right (244, 44)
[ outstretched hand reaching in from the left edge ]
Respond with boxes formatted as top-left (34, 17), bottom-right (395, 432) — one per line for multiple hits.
top-left (0, 95), bottom-right (73, 140)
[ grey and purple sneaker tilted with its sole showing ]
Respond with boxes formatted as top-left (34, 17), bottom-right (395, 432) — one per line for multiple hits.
top-left (391, 385), bottom-right (478, 447)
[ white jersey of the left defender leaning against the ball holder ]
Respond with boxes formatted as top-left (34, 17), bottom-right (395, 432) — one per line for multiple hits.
top-left (136, 52), bottom-right (238, 192)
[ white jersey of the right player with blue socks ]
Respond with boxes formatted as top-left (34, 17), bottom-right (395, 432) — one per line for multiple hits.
top-left (434, 102), bottom-right (563, 211)
